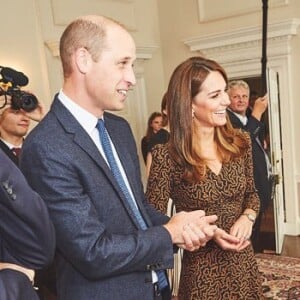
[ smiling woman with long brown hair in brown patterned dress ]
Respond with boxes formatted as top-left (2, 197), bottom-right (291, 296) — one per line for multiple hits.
top-left (146, 57), bottom-right (262, 300)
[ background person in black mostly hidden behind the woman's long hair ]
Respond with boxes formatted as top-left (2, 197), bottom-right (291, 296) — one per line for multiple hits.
top-left (146, 93), bottom-right (170, 177)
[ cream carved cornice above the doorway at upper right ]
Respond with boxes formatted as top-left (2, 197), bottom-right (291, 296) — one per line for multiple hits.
top-left (183, 18), bottom-right (300, 64)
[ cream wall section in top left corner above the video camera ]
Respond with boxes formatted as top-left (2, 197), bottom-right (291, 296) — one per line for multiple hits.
top-left (0, 0), bottom-right (50, 112)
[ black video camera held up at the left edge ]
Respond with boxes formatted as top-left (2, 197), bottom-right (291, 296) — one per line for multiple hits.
top-left (0, 66), bottom-right (38, 112)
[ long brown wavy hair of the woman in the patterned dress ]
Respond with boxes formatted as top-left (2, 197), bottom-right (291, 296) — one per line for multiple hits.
top-left (166, 57), bottom-right (248, 181)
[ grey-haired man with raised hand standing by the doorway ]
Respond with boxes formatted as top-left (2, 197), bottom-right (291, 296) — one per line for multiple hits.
top-left (227, 80), bottom-right (271, 252)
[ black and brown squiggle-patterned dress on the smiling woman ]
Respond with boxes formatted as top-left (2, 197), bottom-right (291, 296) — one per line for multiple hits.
top-left (146, 139), bottom-right (263, 300)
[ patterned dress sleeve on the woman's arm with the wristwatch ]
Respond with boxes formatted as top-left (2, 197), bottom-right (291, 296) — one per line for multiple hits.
top-left (244, 133), bottom-right (260, 214)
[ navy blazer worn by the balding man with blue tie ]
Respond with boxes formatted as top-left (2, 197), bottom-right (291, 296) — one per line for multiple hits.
top-left (21, 98), bottom-right (173, 300)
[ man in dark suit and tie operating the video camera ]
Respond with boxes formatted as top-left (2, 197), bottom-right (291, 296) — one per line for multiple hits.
top-left (0, 95), bottom-right (45, 165)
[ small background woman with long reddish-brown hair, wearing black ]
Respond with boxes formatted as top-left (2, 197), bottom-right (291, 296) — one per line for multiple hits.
top-left (141, 112), bottom-right (162, 164)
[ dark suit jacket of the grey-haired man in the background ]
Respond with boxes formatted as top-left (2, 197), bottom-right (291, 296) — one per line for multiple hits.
top-left (227, 110), bottom-right (271, 212)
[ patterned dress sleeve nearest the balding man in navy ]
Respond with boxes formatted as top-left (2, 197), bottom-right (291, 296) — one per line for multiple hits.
top-left (146, 145), bottom-right (172, 214)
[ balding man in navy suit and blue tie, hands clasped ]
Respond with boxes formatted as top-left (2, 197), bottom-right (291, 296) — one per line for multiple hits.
top-left (21, 16), bottom-right (216, 300)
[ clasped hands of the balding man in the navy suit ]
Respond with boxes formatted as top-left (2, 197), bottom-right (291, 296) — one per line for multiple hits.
top-left (164, 210), bottom-right (217, 251)
